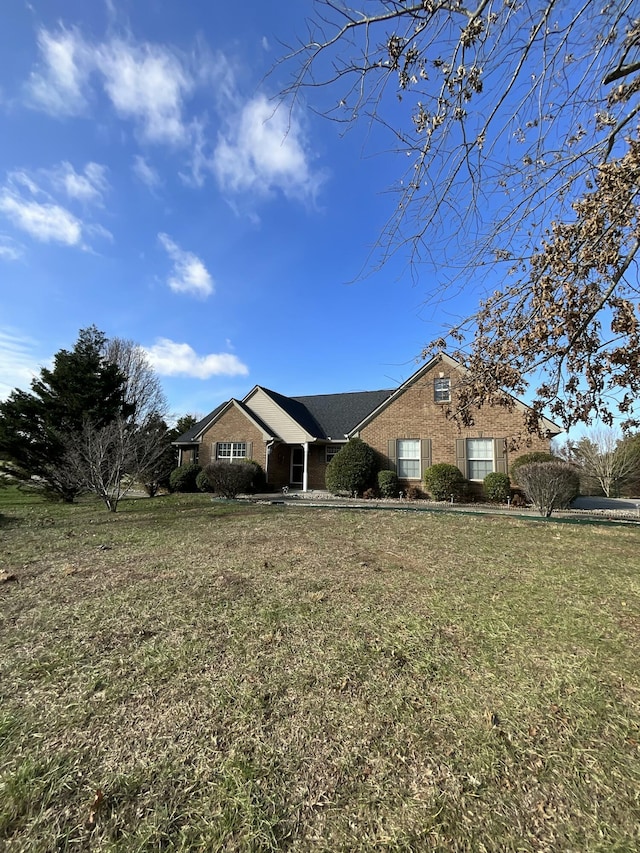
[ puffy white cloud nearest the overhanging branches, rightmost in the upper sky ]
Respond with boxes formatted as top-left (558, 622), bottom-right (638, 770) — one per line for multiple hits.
top-left (213, 95), bottom-right (324, 200)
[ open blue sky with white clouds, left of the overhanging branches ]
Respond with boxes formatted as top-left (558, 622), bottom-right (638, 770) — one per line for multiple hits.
top-left (0, 0), bottom-right (446, 415)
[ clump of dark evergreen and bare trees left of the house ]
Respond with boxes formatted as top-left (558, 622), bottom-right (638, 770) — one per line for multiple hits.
top-left (0, 326), bottom-right (195, 512)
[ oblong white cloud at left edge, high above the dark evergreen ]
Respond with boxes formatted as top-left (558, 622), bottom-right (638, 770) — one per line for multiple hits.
top-left (0, 189), bottom-right (82, 246)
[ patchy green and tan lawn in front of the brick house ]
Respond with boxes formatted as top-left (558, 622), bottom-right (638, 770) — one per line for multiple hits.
top-left (0, 490), bottom-right (640, 853)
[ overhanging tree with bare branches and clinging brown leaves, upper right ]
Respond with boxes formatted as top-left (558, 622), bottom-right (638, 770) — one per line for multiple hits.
top-left (282, 5), bottom-right (640, 431)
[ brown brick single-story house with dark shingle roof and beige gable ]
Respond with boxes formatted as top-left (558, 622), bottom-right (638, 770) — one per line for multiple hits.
top-left (174, 353), bottom-right (561, 491)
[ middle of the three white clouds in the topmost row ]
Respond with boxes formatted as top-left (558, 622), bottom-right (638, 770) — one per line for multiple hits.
top-left (96, 40), bottom-right (193, 145)
